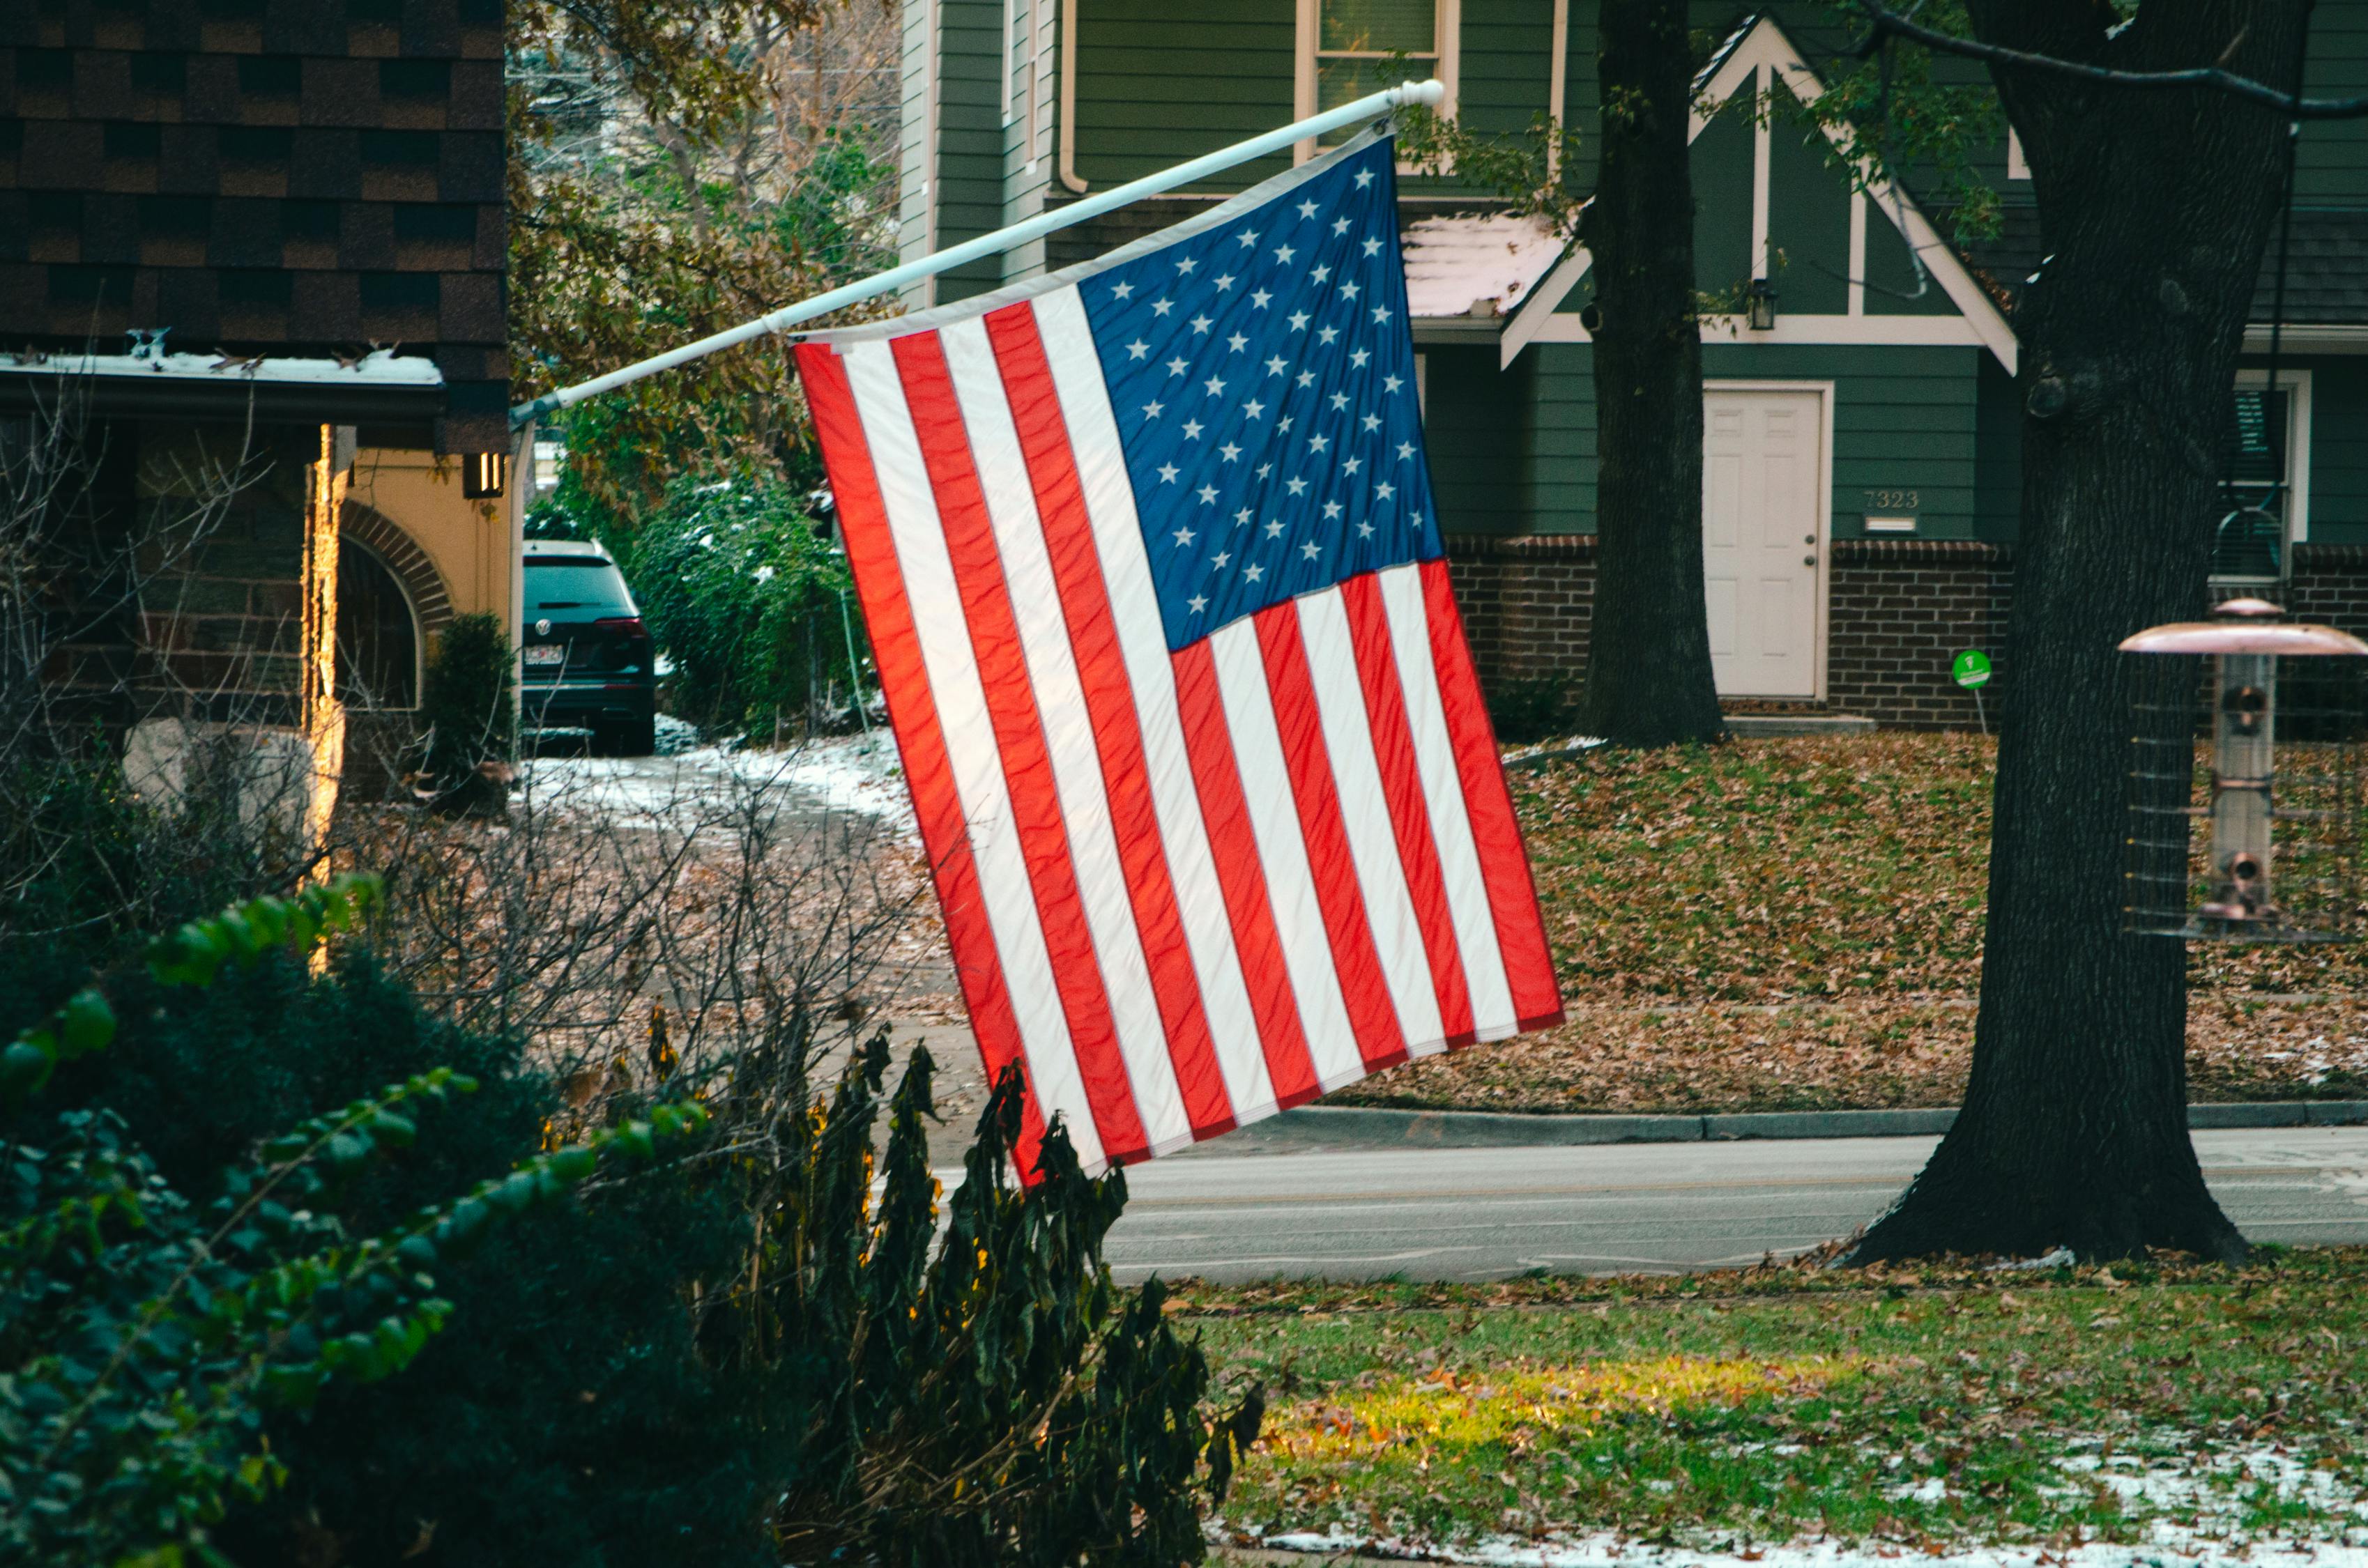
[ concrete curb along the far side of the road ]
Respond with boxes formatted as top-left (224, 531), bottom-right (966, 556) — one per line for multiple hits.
top-left (1224, 1099), bottom-right (2368, 1153)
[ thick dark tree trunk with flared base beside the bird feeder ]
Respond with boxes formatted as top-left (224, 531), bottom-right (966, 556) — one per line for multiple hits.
top-left (1856, 0), bottom-right (2307, 1263)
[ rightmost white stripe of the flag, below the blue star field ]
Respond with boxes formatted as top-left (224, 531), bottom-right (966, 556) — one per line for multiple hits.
top-left (1376, 566), bottom-right (1520, 1040)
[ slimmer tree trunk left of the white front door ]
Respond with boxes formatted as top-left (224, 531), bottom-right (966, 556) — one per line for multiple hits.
top-left (1577, 0), bottom-right (1726, 746)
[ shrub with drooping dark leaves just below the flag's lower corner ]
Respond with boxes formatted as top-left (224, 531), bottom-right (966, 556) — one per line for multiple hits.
top-left (744, 1038), bottom-right (1207, 1568)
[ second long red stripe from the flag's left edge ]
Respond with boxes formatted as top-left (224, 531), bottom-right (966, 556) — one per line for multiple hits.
top-left (888, 332), bottom-right (1151, 1165)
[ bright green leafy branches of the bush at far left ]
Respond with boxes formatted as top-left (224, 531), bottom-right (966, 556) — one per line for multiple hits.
top-left (0, 877), bottom-right (703, 1566)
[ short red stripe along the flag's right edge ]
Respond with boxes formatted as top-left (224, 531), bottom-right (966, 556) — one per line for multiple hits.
top-left (1423, 562), bottom-right (1563, 1028)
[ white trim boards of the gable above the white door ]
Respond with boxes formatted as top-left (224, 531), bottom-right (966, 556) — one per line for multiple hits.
top-left (1506, 14), bottom-right (2026, 374)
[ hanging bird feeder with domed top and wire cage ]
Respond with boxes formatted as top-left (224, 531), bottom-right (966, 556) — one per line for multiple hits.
top-left (2122, 599), bottom-right (2368, 943)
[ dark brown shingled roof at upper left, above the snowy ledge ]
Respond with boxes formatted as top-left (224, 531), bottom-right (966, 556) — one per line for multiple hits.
top-left (0, 0), bottom-right (509, 452)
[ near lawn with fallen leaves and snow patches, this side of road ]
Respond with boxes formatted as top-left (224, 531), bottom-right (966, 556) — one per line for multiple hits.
top-left (1193, 1248), bottom-right (2368, 1549)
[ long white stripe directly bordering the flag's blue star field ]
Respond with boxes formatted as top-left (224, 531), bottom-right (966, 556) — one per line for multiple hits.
top-left (1032, 286), bottom-right (1288, 1123)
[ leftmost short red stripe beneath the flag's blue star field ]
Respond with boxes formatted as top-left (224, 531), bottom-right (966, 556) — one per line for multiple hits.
top-left (1170, 637), bottom-right (1324, 1111)
